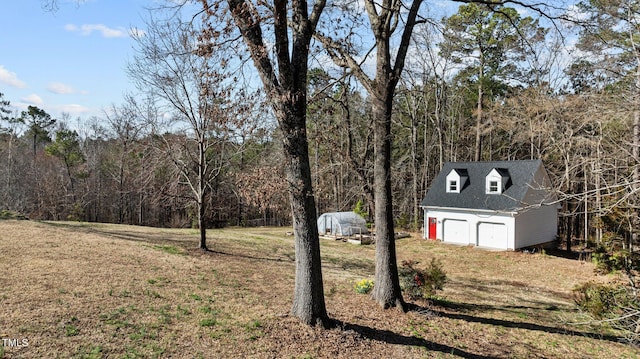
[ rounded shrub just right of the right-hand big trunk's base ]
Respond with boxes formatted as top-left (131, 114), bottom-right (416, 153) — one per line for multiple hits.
top-left (399, 258), bottom-right (447, 299)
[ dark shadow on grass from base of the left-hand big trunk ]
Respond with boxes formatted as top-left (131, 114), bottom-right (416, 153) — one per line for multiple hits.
top-left (336, 322), bottom-right (493, 359)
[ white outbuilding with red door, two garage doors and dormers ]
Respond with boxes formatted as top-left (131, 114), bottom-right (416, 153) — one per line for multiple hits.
top-left (421, 160), bottom-right (558, 250)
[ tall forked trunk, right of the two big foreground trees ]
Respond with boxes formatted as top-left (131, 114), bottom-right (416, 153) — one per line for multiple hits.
top-left (315, 0), bottom-right (422, 310)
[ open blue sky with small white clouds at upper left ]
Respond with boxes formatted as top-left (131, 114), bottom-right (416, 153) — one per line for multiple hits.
top-left (0, 0), bottom-right (153, 119)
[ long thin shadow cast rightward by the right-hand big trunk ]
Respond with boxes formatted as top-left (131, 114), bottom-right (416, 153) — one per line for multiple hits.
top-left (409, 302), bottom-right (620, 343)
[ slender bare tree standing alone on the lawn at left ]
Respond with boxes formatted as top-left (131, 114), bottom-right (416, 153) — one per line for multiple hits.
top-left (127, 15), bottom-right (234, 250)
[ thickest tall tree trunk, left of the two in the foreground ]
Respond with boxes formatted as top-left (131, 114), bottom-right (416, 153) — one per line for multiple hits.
top-left (221, 0), bottom-right (331, 327)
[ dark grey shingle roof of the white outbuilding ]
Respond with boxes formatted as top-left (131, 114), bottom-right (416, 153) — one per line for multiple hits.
top-left (421, 160), bottom-right (542, 211)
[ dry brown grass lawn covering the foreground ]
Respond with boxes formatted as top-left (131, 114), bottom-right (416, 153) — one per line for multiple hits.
top-left (0, 221), bottom-right (638, 358)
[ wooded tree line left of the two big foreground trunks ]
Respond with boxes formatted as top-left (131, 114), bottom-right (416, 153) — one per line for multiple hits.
top-left (0, 97), bottom-right (280, 227)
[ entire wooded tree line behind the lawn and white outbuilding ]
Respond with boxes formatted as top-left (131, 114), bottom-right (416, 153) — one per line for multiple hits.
top-left (0, 1), bottom-right (639, 248)
